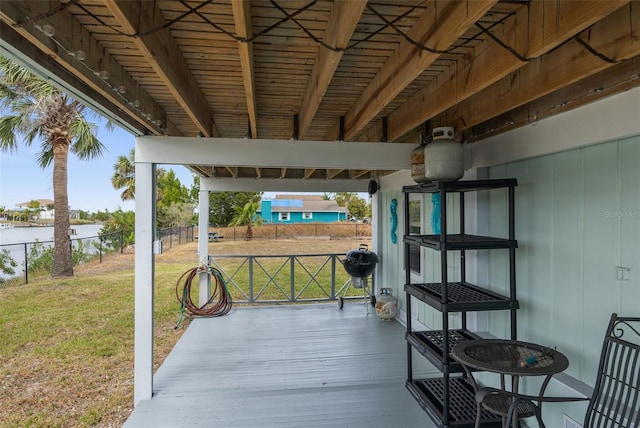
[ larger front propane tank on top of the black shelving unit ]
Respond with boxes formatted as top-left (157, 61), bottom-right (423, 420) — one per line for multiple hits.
top-left (424, 126), bottom-right (464, 181)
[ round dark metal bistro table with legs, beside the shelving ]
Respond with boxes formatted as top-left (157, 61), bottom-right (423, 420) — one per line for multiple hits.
top-left (451, 339), bottom-right (569, 428)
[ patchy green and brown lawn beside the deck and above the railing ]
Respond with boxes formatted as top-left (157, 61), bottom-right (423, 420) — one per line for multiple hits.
top-left (0, 239), bottom-right (368, 428)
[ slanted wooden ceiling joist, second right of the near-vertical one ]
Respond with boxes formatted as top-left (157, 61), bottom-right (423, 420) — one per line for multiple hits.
top-left (326, 0), bottom-right (497, 140)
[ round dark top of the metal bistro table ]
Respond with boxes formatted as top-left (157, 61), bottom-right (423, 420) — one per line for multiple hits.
top-left (451, 339), bottom-right (569, 376)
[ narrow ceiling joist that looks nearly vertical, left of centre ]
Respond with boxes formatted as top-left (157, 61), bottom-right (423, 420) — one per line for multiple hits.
top-left (231, 0), bottom-right (258, 138)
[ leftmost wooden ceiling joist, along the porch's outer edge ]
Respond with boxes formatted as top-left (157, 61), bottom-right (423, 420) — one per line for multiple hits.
top-left (0, 0), bottom-right (168, 136)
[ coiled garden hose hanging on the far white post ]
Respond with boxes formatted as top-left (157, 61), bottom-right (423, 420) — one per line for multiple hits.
top-left (174, 265), bottom-right (233, 328)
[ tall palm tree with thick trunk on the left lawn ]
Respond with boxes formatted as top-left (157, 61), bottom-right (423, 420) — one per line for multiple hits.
top-left (0, 56), bottom-right (111, 277)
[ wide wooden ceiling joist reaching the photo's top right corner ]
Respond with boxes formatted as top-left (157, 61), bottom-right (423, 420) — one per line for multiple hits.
top-left (432, 4), bottom-right (640, 131)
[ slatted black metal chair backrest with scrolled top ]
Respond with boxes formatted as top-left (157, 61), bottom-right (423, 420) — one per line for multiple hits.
top-left (584, 313), bottom-right (640, 428)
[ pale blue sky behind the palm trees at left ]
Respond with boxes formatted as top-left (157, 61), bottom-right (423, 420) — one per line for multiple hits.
top-left (0, 118), bottom-right (193, 212)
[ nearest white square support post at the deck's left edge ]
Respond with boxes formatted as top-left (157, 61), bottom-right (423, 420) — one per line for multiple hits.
top-left (133, 163), bottom-right (156, 406)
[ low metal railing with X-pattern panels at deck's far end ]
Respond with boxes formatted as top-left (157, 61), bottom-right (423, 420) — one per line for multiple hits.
top-left (209, 254), bottom-right (372, 304)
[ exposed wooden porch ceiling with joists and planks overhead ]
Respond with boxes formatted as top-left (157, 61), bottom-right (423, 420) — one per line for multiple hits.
top-left (0, 0), bottom-right (640, 179)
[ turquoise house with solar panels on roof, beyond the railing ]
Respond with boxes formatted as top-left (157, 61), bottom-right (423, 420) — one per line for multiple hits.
top-left (257, 195), bottom-right (347, 224)
